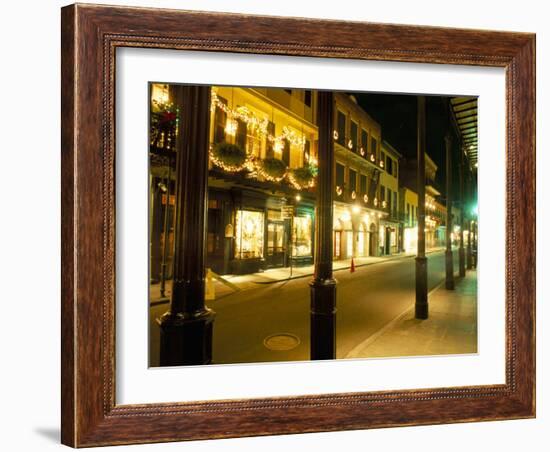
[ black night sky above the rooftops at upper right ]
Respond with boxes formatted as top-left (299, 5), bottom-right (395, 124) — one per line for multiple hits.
top-left (350, 93), bottom-right (466, 199)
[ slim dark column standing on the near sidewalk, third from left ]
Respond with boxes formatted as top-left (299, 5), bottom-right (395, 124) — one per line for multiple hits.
top-left (415, 96), bottom-right (428, 319)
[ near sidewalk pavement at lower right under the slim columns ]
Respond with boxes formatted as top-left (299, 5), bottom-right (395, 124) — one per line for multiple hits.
top-left (346, 270), bottom-right (477, 358)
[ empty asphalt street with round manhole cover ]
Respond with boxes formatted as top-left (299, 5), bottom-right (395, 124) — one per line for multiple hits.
top-left (150, 250), bottom-right (466, 366)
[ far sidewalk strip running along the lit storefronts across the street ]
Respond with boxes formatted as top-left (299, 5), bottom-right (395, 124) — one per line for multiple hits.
top-left (149, 247), bottom-right (445, 304)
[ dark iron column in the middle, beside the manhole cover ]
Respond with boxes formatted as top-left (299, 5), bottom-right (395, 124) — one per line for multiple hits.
top-left (310, 91), bottom-right (336, 360)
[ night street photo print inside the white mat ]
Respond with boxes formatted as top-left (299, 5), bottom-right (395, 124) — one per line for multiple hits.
top-left (148, 83), bottom-right (478, 367)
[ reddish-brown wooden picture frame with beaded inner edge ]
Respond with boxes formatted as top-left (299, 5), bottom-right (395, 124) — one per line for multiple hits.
top-left (61, 4), bottom-right (535, 447)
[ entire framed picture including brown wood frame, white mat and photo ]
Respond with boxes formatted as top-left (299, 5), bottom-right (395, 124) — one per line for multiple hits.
top-left (61, 4), bottom-right (535, 447)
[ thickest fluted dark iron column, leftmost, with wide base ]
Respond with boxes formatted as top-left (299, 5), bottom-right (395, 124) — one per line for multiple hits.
top-left (159, 86), bottom-right (214, 366)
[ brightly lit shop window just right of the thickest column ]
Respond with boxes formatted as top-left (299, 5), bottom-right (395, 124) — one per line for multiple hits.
top-left (235, 210), bottom-right (264, 259)
